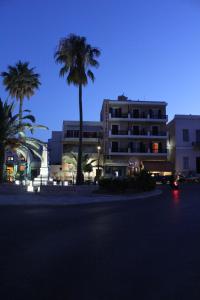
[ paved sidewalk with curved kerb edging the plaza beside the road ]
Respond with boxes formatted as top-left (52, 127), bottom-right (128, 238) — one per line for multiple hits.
top-left (0, 186), bottom-right (162, 206)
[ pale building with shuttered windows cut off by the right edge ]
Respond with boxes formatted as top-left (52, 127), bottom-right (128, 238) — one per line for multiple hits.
top-left (167, 115), bottom-right (200, 175)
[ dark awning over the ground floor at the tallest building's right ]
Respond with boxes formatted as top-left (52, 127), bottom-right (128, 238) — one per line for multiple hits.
top-left (142, 160), bottom-right (173, 172)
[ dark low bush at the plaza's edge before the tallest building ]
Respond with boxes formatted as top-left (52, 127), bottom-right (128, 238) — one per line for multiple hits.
top-left (99, 171), bottom-right (156, 193)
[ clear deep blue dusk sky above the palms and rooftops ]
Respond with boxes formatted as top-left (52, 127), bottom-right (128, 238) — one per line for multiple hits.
top-left (0, 0), bottom-right (200, 140)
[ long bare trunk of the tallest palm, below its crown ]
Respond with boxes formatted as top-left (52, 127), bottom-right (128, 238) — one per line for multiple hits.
top-left (76, 84), bottom-right (84, 185)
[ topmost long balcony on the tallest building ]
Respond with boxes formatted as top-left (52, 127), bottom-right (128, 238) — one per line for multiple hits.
top-left (109, 112), bottom-right (168, 122)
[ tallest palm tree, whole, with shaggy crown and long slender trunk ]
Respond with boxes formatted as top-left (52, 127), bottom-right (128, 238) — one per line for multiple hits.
top-left (55, 34), bottom-right (100, 184)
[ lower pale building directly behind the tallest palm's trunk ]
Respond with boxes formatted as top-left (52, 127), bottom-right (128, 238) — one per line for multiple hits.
top-left (48, 121), bottom-right (102, 180)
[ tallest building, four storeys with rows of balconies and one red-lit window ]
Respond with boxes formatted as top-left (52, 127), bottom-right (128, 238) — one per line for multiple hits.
top-left (101, 96), bottom-right (171, 176)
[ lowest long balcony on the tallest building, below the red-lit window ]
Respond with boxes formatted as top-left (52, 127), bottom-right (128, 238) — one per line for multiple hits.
top-left (109, 148), bottom-right (167, 157)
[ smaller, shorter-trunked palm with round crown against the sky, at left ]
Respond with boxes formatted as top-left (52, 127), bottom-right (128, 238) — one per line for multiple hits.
top-left (1, 61), bottom-right (41, 123)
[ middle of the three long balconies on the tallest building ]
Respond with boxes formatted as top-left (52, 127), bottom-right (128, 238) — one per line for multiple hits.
top-left (109, 130), bottom-right (167, 139)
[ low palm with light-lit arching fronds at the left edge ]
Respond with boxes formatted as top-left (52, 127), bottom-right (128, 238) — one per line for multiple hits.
top-left (0, 99), bottom-right (45, 183)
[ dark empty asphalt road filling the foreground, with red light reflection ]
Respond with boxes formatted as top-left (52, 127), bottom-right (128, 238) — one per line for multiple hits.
top-left (0, 184), bottom-right (200, 300)
